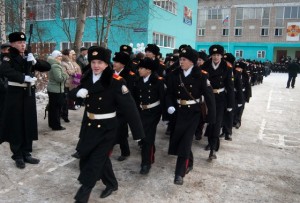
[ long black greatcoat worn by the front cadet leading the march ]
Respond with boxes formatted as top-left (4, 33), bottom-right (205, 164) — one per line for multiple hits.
top-left (70, 67), bottom-right (145, 187)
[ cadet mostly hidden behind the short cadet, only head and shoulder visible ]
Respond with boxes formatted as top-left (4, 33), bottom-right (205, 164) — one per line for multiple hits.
top-left (145, 44), bottom-right (166, 77)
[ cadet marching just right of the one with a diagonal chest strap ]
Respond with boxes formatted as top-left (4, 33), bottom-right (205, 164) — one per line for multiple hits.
top-left (202, 45), bottom-right (234, 161)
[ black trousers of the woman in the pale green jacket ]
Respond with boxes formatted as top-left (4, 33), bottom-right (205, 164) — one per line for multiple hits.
top-left (48, 92), bottom-right (64, 129)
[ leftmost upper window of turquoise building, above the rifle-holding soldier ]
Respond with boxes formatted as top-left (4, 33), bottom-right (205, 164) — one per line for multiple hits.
top-left (26, 0), bottom-right (56, 20)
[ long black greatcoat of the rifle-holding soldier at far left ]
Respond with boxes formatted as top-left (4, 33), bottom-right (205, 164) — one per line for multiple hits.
top-left (0, 48), bottom-right (51, 146)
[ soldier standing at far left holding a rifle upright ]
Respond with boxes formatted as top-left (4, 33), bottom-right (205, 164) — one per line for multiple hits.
top-left (0, 32), bottom-right (51, 169)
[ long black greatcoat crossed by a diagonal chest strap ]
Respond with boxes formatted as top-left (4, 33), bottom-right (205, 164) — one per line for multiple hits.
top-left (166, 67), bottom-right (216, 158)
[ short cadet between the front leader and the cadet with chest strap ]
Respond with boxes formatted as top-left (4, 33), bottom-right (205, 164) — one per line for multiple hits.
top-left (135, 57), bottom-right (165, 175)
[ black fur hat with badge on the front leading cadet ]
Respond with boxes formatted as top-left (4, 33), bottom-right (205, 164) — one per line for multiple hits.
top-left (88, 46), bottom-right (111, 64)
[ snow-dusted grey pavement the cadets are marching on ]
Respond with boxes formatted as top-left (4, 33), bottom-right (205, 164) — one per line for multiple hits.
top-left (0, 73), bottom-right (300, 203)
